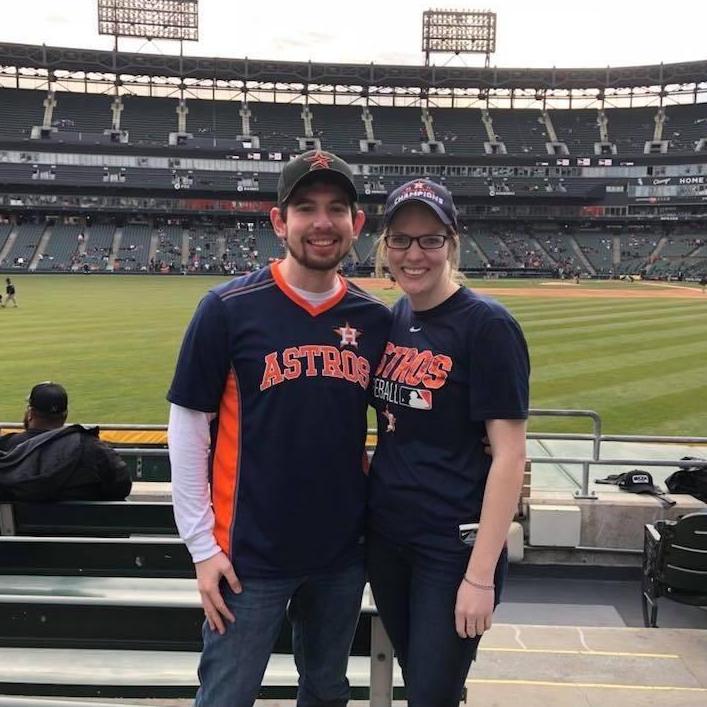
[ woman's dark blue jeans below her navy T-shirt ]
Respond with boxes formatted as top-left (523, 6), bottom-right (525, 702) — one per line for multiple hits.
top-left (367, 533), bottom-right (507, 707)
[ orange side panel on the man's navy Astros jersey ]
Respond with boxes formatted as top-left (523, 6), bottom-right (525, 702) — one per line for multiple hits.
top-left (211, 371), bottom-right (241, 556)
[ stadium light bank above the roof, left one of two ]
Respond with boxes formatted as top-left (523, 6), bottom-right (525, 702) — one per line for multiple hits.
top-left (98, 0), bottom-right (199, 49)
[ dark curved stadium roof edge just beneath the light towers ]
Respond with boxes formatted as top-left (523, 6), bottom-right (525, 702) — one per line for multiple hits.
top-left (0, 43), bottom-right (707, 90)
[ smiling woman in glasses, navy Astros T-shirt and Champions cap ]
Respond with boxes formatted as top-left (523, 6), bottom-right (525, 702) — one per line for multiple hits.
top-left (368, 180), bottom-right (529, 707)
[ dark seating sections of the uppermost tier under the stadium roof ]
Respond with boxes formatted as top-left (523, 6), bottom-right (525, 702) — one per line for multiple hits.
top-left (0, 88), bottom-right (707, 155)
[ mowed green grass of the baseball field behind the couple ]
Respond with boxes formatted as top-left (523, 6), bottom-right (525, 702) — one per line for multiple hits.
top-left (0, 275), bottom-right (707, 436)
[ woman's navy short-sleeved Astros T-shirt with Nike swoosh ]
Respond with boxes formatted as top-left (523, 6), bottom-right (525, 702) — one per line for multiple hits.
top-left (369, 288), bottom-right (529, 552)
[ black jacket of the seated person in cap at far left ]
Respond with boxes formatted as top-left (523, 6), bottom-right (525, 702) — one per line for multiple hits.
top-left (0, 425), bottom-right (132, 502)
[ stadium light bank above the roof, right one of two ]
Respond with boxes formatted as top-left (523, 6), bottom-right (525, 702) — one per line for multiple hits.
top-left (422, 10), bottom-right (496, 67)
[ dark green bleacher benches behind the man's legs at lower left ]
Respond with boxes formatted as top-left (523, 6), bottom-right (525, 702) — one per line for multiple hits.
top-left (0, 501), bottom-right (401, 700)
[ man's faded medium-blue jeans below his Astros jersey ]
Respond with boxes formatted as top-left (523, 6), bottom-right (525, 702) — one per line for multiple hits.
top-left (195, 562), bottom-right (365, 707)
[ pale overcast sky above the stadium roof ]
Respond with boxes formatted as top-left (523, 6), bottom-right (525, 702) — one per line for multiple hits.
top-left (0, 0), bottom-right (707, 67)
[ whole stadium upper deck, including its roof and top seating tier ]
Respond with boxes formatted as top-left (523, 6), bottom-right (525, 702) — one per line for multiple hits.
top-left (0, 44), bottom-right (707, 157)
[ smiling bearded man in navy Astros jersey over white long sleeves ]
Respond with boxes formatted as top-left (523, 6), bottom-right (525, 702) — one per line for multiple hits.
top-left (167, 151), bottom-right (390, 707)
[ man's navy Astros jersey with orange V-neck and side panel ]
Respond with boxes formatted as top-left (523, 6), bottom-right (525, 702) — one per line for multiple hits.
top-left (167, 264), bottom-right (390, 577)
